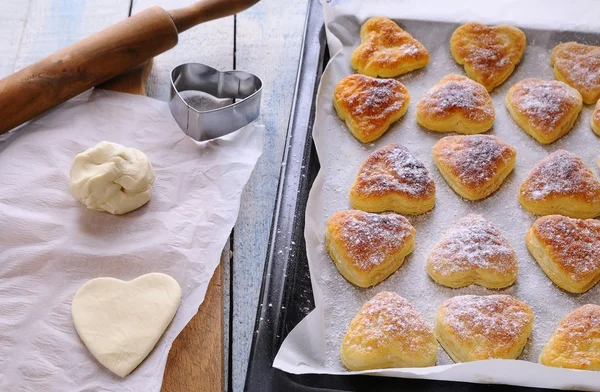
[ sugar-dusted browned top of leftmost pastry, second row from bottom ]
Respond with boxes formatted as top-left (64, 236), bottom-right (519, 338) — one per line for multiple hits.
top-left (330, 210), bottom-right (415, 271)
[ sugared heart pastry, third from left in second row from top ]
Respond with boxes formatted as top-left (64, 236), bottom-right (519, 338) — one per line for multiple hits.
top-left (505, 78), bottom-right (583, 144)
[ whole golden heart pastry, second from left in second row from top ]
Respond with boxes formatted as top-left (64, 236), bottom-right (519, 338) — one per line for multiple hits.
top-left (417, 74), bottom-right (496, 135)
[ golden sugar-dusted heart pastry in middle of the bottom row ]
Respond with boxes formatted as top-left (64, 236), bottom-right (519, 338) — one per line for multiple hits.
top-left (435, 295), bottom-right (533, 362)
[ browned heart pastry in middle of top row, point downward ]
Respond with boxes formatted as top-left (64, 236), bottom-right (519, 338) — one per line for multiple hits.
top-left (450, 23), bottom-right (527, 91)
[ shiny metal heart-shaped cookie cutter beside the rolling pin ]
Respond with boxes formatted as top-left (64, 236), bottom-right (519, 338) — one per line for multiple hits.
top-left (169, 63), bottom-right (263, 141)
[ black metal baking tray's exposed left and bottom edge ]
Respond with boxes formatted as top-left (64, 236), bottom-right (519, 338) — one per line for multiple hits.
top-left (244, 0), bottom-right (548, 392)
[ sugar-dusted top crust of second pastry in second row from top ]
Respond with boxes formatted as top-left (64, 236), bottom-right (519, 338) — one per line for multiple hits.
top-left (418, 75), bottom-right (495, 122)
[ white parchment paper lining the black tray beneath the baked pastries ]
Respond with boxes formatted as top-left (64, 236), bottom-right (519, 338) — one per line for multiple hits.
top-left (274, 0), bottom-right (600, 390)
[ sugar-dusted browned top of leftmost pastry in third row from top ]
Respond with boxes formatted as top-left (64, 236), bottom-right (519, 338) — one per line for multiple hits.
top-left (355, 144), bottom-right (435, 198)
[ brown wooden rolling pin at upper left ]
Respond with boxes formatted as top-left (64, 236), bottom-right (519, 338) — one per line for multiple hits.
top-left (0, 0), bottom-right (258, 135)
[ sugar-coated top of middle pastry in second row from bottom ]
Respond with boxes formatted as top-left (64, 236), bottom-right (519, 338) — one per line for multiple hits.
top-left (428, 214), bottom-right (517, 276)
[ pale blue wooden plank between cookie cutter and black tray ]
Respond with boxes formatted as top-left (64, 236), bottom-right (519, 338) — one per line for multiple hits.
top-left (231, 0), bottom-right (307, 391)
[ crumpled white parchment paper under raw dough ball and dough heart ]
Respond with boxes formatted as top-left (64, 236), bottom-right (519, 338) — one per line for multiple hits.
top-left (0, 90), bottom-right (263, 392)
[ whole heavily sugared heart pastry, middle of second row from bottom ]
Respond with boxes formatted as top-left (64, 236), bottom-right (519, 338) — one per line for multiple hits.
top-left (427, 215), bottom-right (518, 289)
